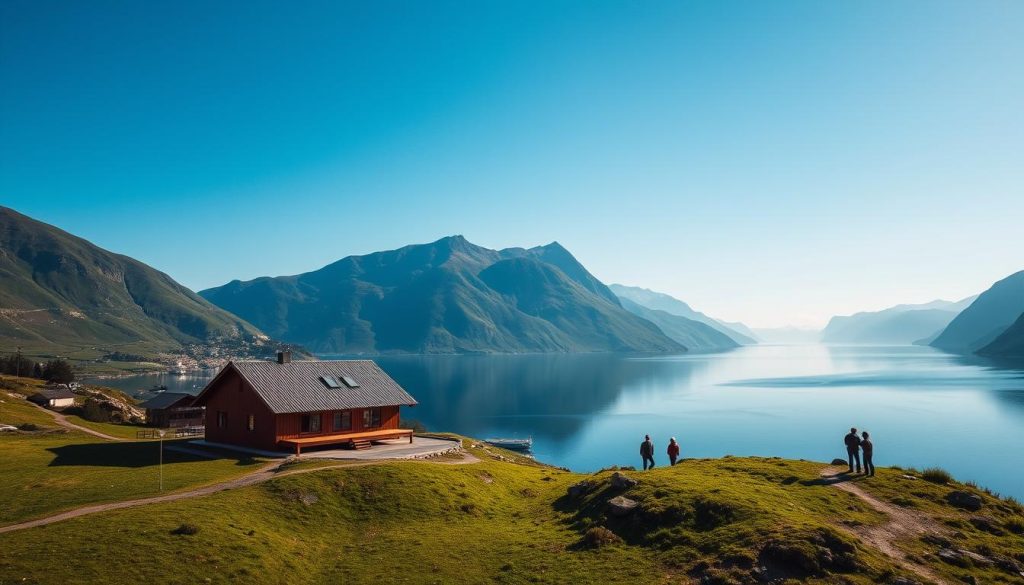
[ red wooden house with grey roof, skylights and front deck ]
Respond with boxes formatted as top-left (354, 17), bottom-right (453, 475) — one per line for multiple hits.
top-left (194, 351), bottom-right (416, 455)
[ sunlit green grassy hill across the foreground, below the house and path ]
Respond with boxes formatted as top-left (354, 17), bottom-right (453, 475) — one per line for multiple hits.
top-left (0, 442), bottom-right (1024, 584)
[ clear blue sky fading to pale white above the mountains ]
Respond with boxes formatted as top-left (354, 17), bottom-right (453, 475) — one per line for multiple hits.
top-left (0, 0), bottom-right (1024, 326)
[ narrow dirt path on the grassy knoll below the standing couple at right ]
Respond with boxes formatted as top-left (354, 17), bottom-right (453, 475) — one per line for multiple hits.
top-left (821, 467), bottom-right (946, 585)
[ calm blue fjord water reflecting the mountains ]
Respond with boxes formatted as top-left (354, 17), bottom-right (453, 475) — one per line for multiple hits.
top-left (92, 345), bottom-right (1024, 498)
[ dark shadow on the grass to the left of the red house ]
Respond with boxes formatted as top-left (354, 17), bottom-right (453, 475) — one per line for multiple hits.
top-left (47, 441), bottom-right (257, 468)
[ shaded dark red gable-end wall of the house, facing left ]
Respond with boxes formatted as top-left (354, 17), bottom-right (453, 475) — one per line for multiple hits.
top-left (205, 370), bottom-right (278, 450)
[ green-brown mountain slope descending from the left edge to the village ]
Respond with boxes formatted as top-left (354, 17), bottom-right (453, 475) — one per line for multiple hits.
top-left (0, 207), bottom-right (265, 351)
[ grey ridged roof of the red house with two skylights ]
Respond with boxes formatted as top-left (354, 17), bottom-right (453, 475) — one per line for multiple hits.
top-left (197, 360), bottom-right (417, 414)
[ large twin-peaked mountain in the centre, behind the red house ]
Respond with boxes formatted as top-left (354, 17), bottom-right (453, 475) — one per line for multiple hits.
top-left (200, 236), bottom-right (685, 353)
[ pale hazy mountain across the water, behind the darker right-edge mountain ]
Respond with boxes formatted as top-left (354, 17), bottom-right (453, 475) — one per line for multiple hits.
top-left (821, 296), bottom-right (977, 344)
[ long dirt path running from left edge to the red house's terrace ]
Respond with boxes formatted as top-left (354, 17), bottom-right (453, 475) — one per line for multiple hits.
top-left (0, 450), bottom-right (479, 534)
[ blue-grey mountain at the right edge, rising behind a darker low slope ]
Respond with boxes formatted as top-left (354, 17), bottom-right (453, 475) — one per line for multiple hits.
top-left (931, 270), bottom-right (1024, 353)
